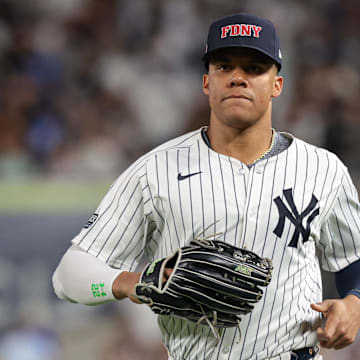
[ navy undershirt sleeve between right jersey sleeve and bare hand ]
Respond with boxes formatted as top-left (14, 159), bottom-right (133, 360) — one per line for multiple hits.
top-left (335, 260), bottom-right (360, 298)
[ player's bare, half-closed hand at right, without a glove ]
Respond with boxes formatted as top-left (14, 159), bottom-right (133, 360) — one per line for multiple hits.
top-left (311, 295), bottom-right (360, 349)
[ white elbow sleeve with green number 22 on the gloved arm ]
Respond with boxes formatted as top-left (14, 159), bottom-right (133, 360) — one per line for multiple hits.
top-left (52, 245), bottom-right (123, 305)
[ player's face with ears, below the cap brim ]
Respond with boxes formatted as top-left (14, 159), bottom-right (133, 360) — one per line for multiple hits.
top-left (203, 48), bottom-right (283, 129)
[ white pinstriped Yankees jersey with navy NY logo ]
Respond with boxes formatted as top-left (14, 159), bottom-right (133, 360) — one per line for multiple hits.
top-left (73, 130), bottom-right (360, 360)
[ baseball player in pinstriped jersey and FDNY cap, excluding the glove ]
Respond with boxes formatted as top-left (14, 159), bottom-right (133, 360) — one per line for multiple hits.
top-left (53, 14), bottom-right (360, 360)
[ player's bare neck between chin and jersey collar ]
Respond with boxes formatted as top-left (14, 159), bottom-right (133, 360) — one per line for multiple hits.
top-left (207, 121), bottom-right (273, 165)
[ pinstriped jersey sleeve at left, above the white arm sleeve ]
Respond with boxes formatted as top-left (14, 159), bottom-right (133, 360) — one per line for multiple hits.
top-left (72, 162), bottom-right (151, 271)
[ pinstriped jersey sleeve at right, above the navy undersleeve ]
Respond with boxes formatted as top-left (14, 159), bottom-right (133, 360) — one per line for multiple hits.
top-left (319, 168), bottom-right (360, 272)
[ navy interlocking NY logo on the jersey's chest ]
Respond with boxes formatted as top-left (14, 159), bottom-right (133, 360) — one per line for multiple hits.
top-left (274, 189), bottom-right (320, 247)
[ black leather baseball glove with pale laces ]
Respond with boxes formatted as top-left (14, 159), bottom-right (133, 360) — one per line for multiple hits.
top-left (135, 240), bottom-right (272, 338)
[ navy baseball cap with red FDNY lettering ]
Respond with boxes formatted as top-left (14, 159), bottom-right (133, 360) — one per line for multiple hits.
top-left (202, 13), bottom-right (282, 71)
